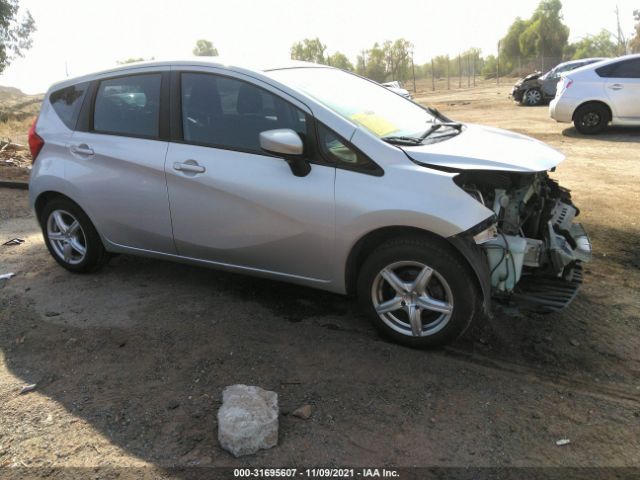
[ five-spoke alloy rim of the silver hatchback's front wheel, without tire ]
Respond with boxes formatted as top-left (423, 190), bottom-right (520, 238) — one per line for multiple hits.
top-left (371, 261), bottom-right (454, 337)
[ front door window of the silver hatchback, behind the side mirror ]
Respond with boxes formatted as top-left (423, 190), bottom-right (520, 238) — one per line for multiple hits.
top-left (181, 72), bottom-right (307, 153)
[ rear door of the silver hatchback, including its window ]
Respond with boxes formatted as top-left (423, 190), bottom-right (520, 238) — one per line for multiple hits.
top-left (66, 69), bottom-right (175, 253)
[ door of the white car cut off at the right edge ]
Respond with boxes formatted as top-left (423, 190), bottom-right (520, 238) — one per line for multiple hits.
top-left (597, 58), bottom-right (640, 123)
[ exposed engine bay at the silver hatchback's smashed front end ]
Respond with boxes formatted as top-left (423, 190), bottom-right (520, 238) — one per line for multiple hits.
top-left (454, 170), bottom-right (591, 311)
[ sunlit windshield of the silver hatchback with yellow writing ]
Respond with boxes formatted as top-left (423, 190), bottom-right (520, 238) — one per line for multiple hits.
top-left (268, 68), bottom-right (436, 137)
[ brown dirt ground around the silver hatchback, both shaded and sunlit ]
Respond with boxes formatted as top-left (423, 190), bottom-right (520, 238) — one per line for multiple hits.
top-left (0, 79), bottom-right (640, 478)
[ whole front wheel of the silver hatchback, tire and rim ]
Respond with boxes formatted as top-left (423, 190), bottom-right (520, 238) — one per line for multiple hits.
top-left (358, 237), bottom-right (478, 348)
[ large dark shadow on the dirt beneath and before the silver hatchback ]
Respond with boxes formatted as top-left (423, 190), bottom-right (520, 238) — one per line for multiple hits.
top-left (0, 230), bottom-right (636, 476)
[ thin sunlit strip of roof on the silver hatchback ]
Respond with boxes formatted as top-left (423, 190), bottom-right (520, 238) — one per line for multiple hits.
top-left (49, 57), bottom-right (333, 91)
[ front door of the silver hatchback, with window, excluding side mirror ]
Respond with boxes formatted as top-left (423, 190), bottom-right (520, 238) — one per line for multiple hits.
top-left (166, 70), bottom-right (335, 281)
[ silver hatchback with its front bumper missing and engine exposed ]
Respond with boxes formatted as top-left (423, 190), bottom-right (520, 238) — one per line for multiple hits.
top-left (29, 59), bottom-right (591, 347)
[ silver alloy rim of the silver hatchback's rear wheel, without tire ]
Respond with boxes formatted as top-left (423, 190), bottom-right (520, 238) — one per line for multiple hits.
top-left (47, 210), bottom-right (87, 265)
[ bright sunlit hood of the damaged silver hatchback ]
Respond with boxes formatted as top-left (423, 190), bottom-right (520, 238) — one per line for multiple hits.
top-left (402, 124), bottom-right (564, 172)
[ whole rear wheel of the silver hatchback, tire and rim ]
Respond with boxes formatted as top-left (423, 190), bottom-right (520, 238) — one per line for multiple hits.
top-left (40, 198), bottom-right (108, 273)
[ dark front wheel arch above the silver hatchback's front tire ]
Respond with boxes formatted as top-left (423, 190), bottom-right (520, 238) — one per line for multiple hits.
top-left (345, 226), bottom-right (491, 312)
